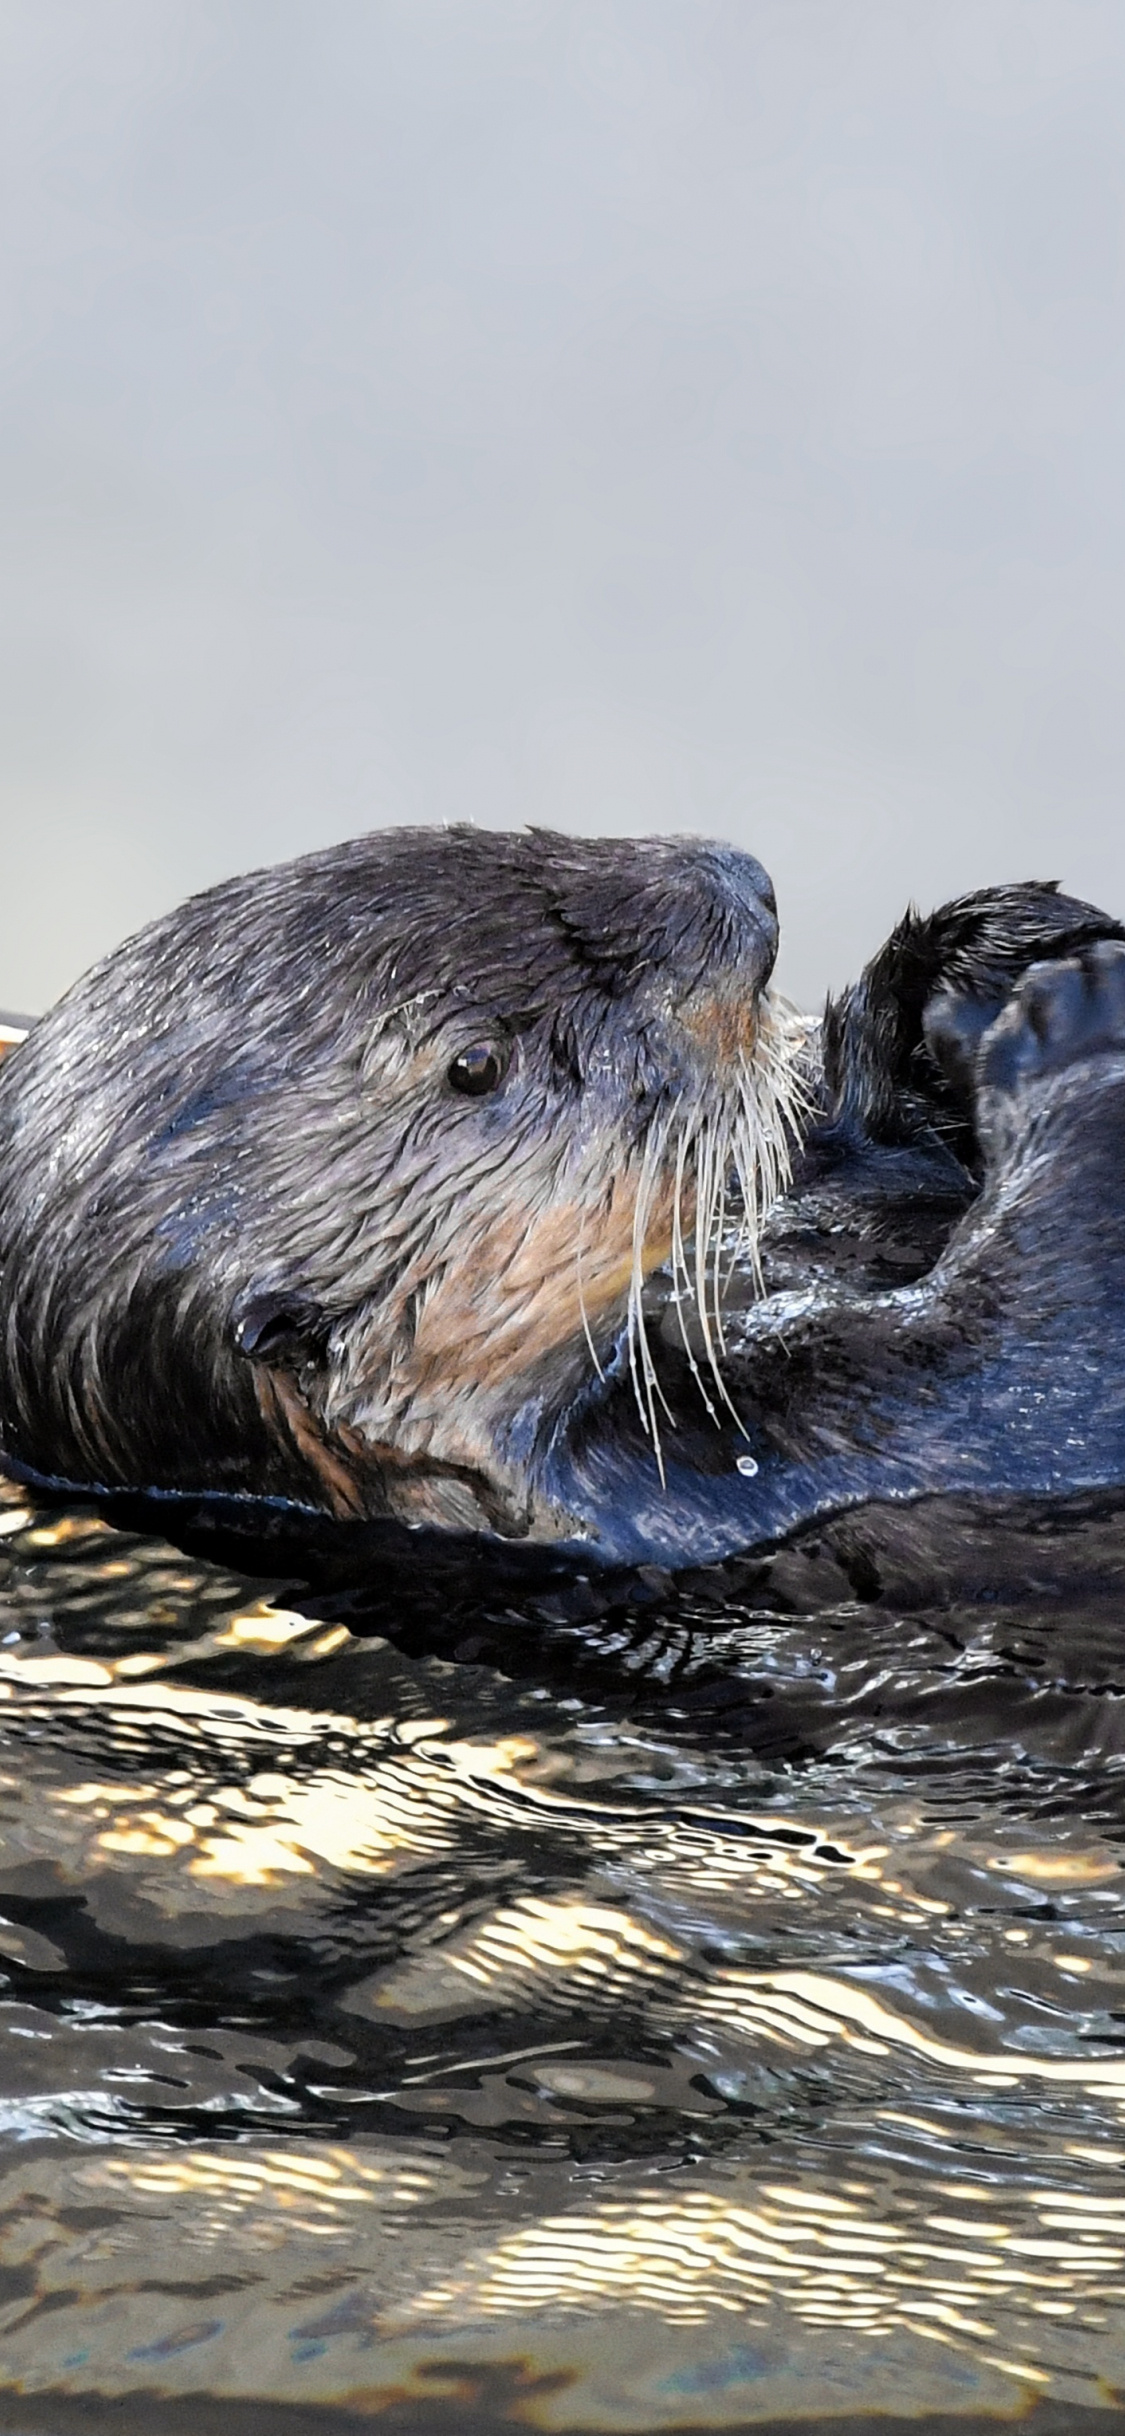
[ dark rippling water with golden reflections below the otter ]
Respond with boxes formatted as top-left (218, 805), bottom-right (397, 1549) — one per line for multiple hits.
top-left (0, 1491), bottom-right (1125, 2436)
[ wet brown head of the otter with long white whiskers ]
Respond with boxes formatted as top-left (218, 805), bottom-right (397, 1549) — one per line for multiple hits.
top-left (0, 828), bottom-right (794, 1537)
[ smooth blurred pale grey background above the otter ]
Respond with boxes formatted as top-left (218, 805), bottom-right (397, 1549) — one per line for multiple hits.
top-left (0, 0), bottom-right (1125, 1011)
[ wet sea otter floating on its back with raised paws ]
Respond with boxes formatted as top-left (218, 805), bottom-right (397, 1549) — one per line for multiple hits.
top-left (0, 828), bottom-right (1125, 1566)
